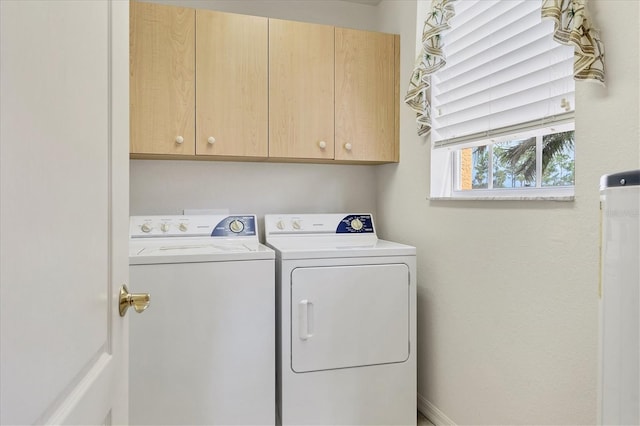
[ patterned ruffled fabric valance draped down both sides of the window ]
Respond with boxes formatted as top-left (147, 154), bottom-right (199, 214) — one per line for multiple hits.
top-left (404, 0), bottom-right (605, 136)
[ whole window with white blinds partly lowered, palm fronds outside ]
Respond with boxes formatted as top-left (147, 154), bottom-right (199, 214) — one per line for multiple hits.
top-left (431, 0), bottom-right (575, 199)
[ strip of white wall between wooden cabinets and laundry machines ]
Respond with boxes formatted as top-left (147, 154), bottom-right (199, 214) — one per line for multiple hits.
top-left (130, 160), bottom-right (376, 216)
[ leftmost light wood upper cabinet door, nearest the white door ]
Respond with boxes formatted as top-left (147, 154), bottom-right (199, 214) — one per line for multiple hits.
top-left (129, 1), bottom-right (195, 155)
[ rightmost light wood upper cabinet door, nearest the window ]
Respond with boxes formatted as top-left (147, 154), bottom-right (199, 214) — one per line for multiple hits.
top-left (335, 28), bottom-right (400, 162)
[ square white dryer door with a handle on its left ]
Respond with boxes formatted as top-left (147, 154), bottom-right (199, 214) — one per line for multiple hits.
top-left (291, 264), bottom-right (409, 373)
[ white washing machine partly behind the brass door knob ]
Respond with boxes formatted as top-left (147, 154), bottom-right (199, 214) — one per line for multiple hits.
top-left (129, 215), bottom-right (275, 425)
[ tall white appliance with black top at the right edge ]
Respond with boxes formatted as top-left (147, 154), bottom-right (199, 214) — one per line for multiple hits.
top-left (598, 170), bottom-right (640, 425)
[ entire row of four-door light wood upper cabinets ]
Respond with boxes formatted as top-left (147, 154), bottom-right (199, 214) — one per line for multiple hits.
top-left (130, 1), bottom-right (399, 164)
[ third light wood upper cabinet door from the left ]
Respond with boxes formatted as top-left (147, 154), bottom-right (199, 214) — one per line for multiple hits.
top-left (269, 19), bottom-right (334, 159)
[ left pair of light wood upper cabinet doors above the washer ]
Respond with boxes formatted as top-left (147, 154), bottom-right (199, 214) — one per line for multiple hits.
top-left (130, 1), bottom-right (268, 158)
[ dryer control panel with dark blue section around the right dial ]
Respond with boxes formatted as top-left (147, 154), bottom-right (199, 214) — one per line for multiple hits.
top-left (264, 213), bottom-right (375, 235)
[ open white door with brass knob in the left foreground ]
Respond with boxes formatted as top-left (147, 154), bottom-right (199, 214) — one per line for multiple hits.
top-left (0, 0), bottom-right (129, 424)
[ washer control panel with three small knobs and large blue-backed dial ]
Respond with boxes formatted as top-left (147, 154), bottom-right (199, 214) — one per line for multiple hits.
top-left (129, 215), bottom-right (258, 239)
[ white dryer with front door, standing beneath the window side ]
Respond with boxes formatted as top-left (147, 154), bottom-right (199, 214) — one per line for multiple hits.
top-left (265, 214), bottom-right (417, 425)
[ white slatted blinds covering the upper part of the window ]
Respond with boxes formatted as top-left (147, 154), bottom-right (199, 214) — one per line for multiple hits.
top-left (431, 0), bottom-right (575, 147)
